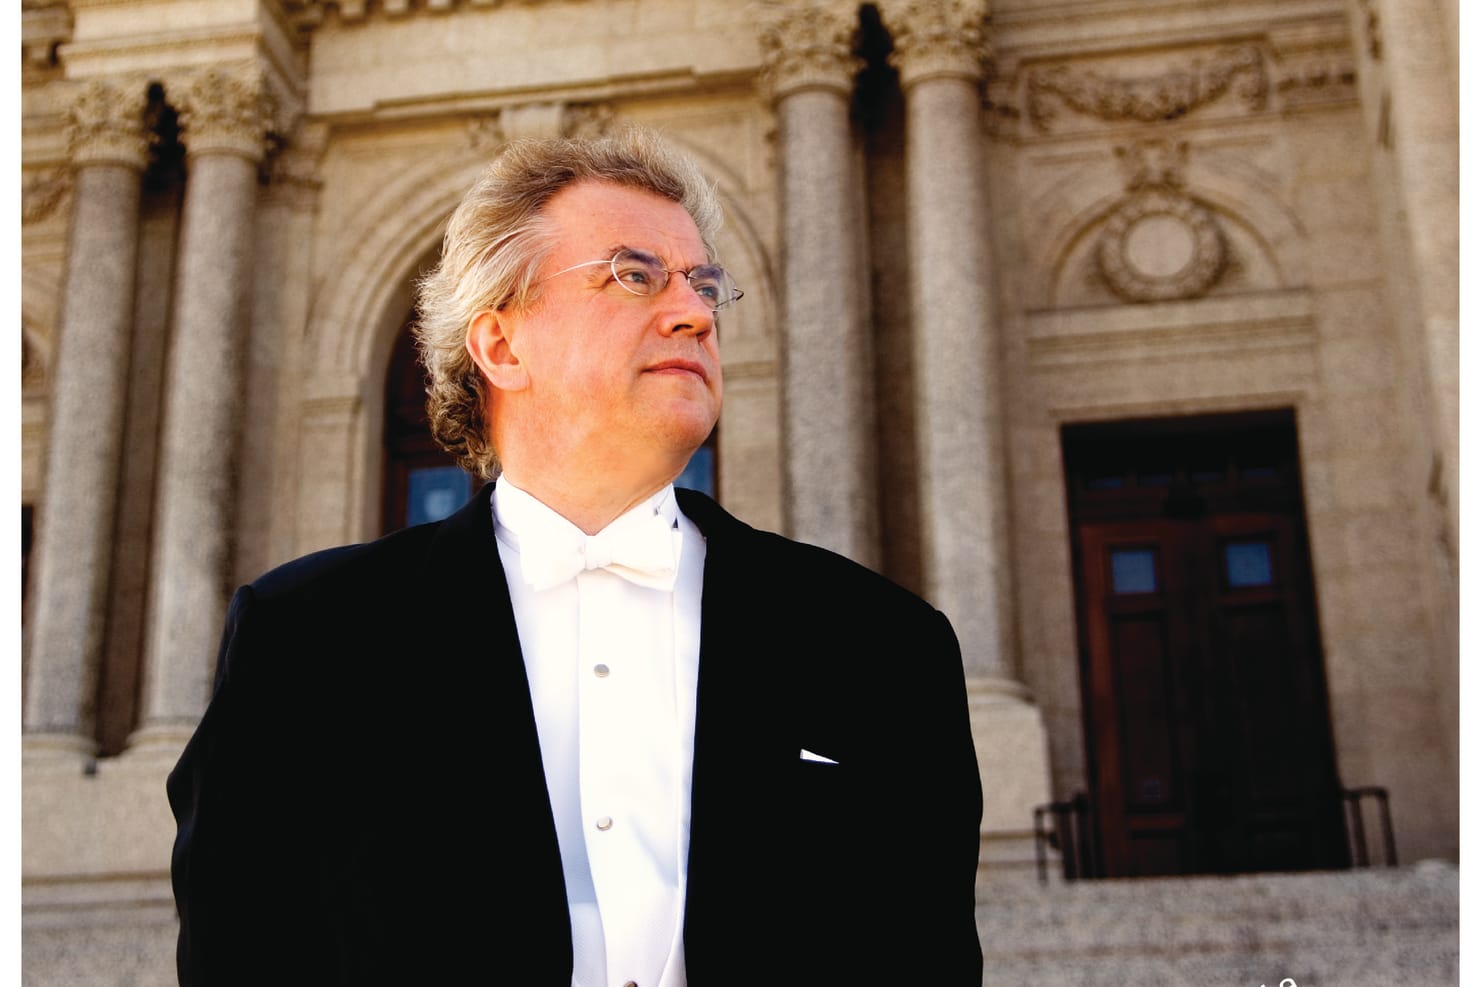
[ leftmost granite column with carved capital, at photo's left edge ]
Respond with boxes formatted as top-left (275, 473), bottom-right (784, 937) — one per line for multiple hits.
top-left (24, 81), bottom-right (148, 761)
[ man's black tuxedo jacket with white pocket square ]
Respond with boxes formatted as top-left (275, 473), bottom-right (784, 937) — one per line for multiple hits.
top-left (169, 485), bottom-right (981, 987)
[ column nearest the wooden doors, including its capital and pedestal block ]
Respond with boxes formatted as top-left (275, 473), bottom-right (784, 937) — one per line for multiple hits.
top-left (887, 0), bottom-right (1049, 876)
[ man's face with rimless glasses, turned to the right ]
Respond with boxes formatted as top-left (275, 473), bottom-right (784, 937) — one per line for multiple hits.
top-left (496, 182), bottom-right (722, 482)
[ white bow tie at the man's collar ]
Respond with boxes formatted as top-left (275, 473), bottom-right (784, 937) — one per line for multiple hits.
top-left (519, 515), bottom-right (684, 592)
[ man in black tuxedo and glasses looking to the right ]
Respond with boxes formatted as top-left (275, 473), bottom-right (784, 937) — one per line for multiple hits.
top-left (169, 133), bottom-right (981, 987)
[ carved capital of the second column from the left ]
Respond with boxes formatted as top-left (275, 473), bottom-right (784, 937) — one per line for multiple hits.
top-left (172, 68), bottom-right (272, 161)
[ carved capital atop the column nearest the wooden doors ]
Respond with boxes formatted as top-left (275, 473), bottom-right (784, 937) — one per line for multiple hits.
top-left (884, 0), bottom-right (990, 89)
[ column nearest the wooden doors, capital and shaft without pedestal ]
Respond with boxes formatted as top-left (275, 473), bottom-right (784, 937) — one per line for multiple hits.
top-left (891, 0), bottom-right (1014, 679)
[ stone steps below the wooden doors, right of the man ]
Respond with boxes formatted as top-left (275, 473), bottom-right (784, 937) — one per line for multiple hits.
top-left (977, 861), bottom-right (1459, 987)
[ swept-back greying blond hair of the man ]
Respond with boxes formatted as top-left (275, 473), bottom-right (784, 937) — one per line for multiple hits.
top-left (411, 129), bottom-right (722, 479)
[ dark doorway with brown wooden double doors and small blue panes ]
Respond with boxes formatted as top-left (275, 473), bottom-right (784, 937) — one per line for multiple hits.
top-left (1063, 411), bottom-right (1347, 876)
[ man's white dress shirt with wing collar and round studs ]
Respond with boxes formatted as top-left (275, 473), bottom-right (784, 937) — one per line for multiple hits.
top-left (493, 479), bottom-right (704, 987)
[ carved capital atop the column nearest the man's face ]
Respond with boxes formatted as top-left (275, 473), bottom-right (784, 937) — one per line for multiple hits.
top-left (761, 0), bottom-right (863, 102)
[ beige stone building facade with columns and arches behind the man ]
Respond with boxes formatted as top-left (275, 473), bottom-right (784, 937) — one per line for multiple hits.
top-left (21, 0), bottom-right (1459, 984)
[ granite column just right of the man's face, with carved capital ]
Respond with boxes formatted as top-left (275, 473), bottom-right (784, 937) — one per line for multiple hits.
top-left (761, 1), bottom-right (879, 567)
